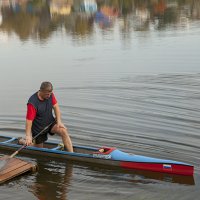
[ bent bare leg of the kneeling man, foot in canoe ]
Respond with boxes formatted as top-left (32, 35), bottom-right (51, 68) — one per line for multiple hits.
top-left (51, 124), bottom-right (73, 152)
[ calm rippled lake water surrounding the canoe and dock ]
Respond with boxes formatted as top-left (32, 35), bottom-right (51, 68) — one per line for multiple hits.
top-left (0, 0), bottom-right (200, 200)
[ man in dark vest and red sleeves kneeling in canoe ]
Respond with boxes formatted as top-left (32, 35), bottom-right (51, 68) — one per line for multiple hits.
top-left (26, 82), bottom-right (73, 152)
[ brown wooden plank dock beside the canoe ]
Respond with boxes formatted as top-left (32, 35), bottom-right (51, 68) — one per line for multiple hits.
top-left (0, 156), bottom-right (37, 184)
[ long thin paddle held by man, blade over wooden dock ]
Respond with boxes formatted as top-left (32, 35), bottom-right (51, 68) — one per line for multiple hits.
top-left (0, 121), bottom-right (55, 170)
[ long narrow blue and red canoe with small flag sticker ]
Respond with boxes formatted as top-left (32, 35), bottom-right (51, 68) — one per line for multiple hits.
top-left (0, 136), bottom-right (194, 176)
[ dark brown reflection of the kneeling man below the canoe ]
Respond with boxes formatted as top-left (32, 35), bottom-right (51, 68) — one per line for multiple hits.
top-left (31, 160), bottom-right (73, 200)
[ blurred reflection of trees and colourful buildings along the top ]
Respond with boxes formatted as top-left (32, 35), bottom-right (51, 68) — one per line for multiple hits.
top-left (0, 0), bottom-right (200, 40)
